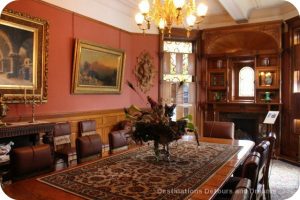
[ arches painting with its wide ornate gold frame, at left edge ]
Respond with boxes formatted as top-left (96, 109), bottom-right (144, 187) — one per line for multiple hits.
top-left (0, 10), bottom-right (48, 103)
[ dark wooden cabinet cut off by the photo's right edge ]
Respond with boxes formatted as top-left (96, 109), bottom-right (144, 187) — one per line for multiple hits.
top-left (283, 17), bottom-right (300, 162)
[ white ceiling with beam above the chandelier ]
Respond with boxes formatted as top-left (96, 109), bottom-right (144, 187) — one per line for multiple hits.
top-left (43, 0), bottom-right (298, 33)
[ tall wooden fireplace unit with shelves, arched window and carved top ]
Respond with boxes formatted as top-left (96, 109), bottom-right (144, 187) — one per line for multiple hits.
top-left (199, 21), bottom-right (283, 155)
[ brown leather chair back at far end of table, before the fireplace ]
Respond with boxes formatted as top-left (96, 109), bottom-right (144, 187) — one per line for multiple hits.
top-left (203, 121), bottom-right (234, 139)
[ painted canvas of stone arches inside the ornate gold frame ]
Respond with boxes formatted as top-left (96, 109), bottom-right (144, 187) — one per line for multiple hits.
top-left (0, 19), bottom-right (34, 87)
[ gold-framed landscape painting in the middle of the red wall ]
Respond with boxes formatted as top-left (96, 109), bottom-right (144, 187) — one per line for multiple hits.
top-left (72, 39), bottom-right (125, 94)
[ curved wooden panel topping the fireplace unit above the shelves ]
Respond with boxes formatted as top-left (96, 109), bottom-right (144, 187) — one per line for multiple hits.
top-left (203, 21), bottom-right (281, 55)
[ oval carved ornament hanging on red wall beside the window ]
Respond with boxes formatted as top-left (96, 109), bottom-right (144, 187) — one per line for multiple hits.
top-left (134, 51), bottom-right (154, 93)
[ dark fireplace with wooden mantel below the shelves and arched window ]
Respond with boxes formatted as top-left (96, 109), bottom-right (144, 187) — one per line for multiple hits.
top-left (204, 102), bottom-right (282, 142)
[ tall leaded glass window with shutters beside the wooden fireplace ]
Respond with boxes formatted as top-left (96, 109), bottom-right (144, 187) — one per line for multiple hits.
top-left (160, 41), bottom-right (196, 120)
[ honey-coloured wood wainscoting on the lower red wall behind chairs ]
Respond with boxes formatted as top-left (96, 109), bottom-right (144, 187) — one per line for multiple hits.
top-left (6, 109), bottom-right (125, 147)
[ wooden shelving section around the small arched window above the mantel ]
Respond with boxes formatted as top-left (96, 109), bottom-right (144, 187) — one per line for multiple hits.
top-left (207, 54), bottom-right (282, 104)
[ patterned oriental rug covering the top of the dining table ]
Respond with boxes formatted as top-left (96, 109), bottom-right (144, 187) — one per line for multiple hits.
top-left (38, 142), bottom-right (240, 199)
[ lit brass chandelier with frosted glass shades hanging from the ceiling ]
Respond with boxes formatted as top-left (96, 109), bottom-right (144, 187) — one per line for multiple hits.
top-left (135, 0), bottom-right (208, 37)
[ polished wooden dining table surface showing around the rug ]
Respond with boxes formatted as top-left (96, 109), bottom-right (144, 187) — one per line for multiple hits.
top-left (3, 136), bottom-right (254, 200)
